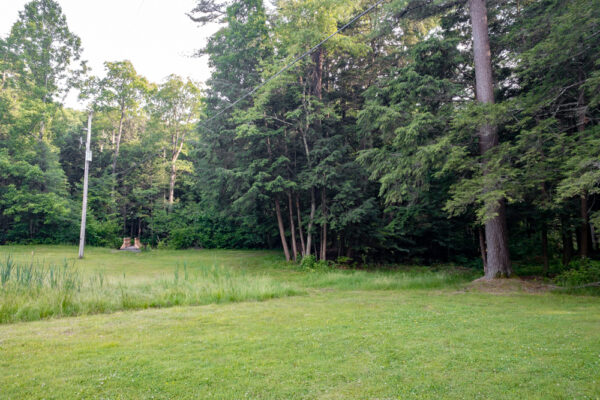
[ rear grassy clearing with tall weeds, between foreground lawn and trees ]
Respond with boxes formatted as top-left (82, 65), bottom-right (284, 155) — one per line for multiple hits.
top-left (0, 246), bottom-right (473, 323)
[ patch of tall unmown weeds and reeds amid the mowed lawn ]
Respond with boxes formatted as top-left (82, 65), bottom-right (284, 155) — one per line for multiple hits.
top-left (0, 256), bottom-right (297, 323)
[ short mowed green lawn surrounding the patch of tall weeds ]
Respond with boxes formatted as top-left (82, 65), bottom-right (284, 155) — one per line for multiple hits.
top-left (0, 247), bottom-right (600, 399)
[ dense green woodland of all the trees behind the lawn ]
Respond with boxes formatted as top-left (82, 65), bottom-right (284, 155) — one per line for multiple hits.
top-left (0, 0), bottom-right (600, 277)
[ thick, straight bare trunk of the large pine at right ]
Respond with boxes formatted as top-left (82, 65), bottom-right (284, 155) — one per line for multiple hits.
top-left (469, 0), bottom-right (512, 279)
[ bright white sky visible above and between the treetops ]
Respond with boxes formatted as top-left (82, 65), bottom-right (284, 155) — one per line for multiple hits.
top-left (0, 0), bottom-right (218, 108)
